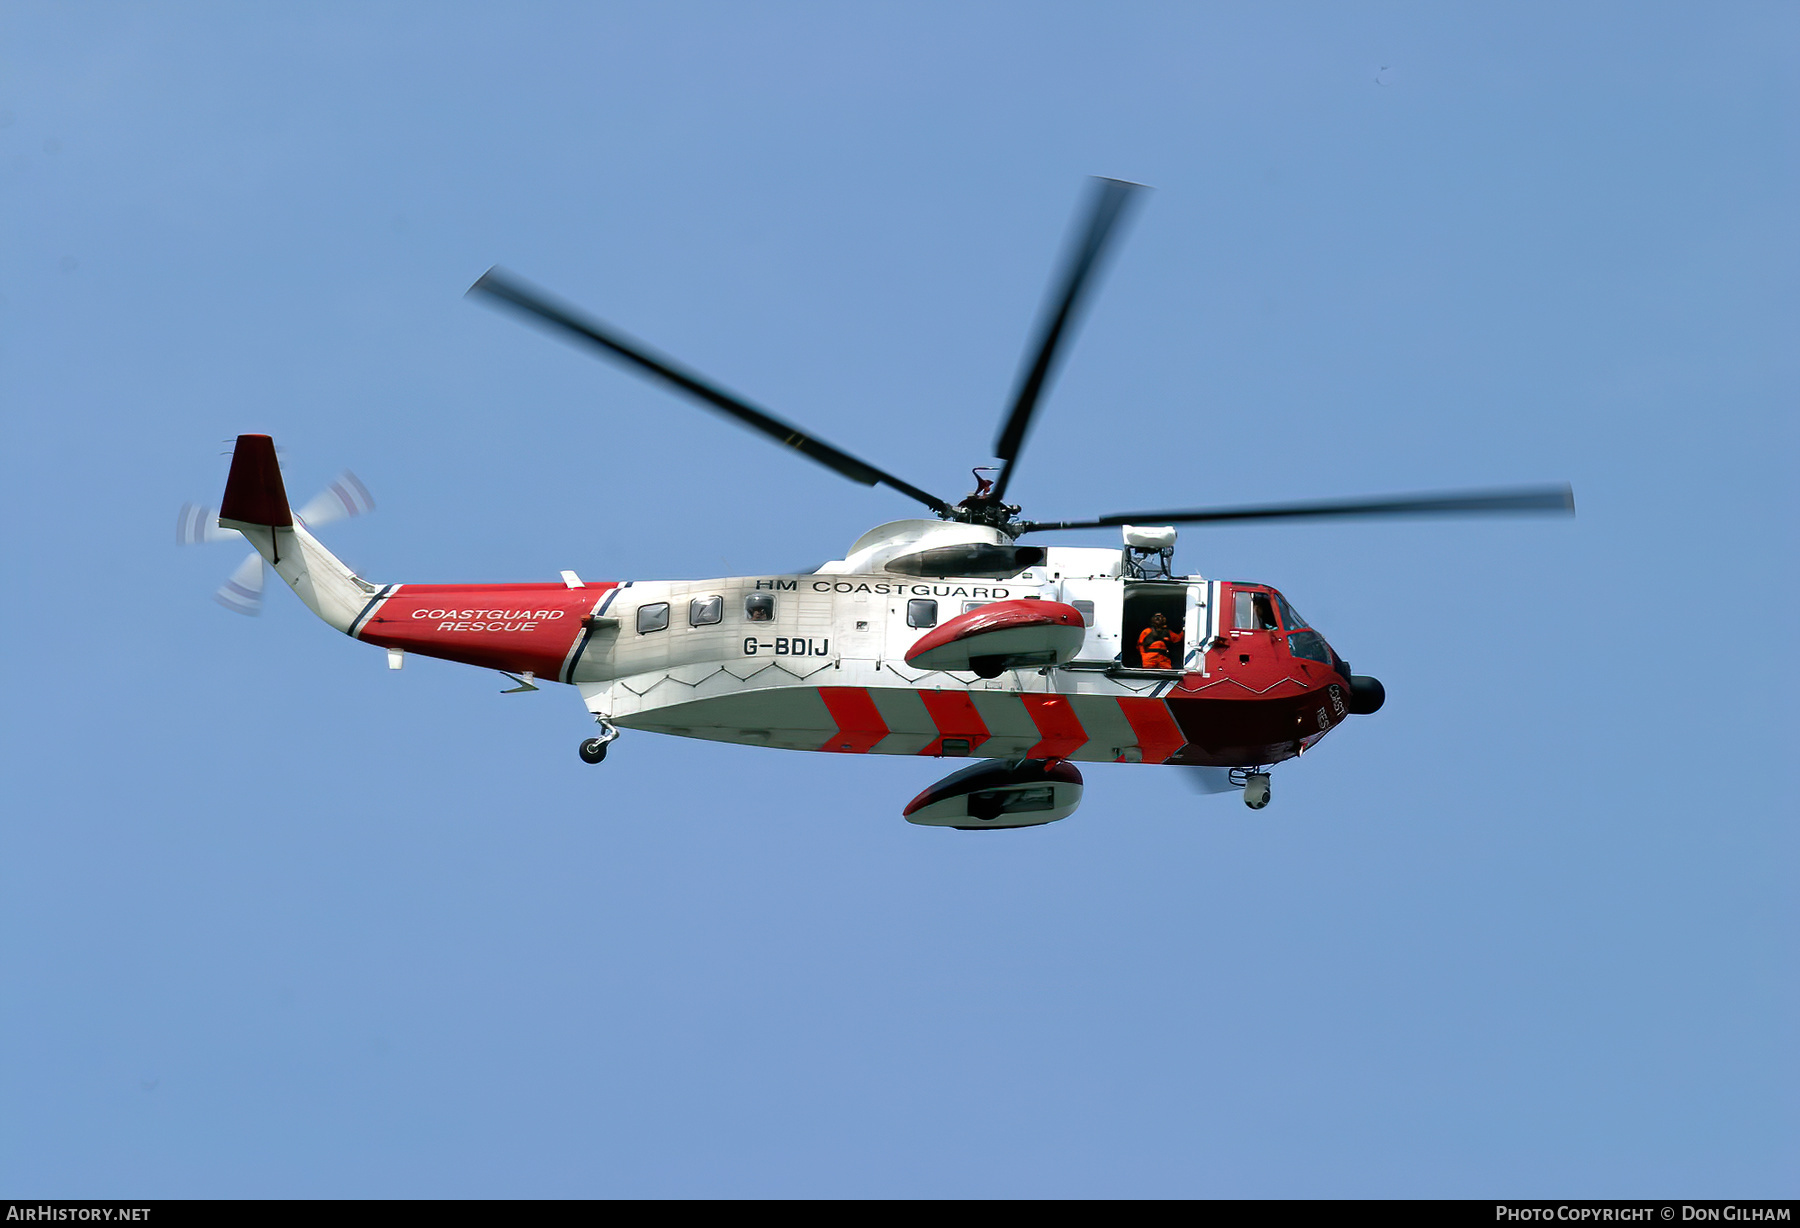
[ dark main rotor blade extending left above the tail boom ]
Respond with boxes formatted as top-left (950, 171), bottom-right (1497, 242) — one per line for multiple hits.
top-left (468, 266), bottom-right (950, 513)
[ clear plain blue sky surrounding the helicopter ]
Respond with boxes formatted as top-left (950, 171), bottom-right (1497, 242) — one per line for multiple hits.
top-left (0, 4), bottom-right (1800, 1197)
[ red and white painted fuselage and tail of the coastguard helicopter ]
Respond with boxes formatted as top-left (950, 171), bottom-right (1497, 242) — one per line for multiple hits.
top-left (218, 436), bottom-right (1404, 826)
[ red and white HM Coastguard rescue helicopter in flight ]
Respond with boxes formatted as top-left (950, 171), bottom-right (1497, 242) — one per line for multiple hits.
top-left (182, 178), bottom-right (1575, 830)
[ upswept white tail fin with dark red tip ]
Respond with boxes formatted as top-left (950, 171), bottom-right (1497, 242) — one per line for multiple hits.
top-left (220, 436), bottom-right (378, 634)
